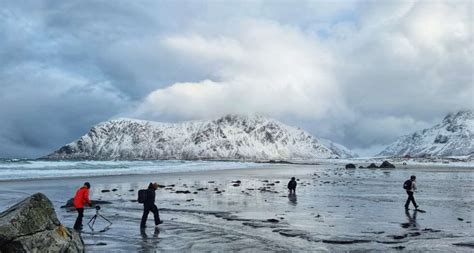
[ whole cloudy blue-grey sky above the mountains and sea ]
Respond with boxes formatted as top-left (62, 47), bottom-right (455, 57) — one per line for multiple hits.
top-left (0, 0), bottom-right (474, 158)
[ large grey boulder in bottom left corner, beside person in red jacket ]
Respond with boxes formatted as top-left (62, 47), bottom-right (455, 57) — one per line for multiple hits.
top-left (0, 193), bottom-right (84, 253)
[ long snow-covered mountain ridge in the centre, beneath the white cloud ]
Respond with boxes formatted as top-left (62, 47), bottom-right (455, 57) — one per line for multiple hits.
top-left (46, 115), bottom-right (351, 160)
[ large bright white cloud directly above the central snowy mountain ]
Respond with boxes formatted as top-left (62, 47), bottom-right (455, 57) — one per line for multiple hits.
top-left (131, 20), bottom-right (348, 122)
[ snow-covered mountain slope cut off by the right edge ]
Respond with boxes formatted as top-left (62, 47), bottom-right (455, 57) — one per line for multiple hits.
top-left (378, 110), bottom-right (474, 157)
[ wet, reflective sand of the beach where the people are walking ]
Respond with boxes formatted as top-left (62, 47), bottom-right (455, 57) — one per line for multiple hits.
top-left (0, 164), bottom-right (474, 252)
